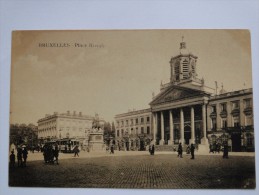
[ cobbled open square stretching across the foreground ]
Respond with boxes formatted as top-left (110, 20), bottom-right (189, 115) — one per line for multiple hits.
top-left (9, 151), bottom-right (255, 189)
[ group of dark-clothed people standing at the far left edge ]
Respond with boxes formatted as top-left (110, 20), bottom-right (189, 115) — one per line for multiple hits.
top-left (10, 147), bottom-right (28, 167)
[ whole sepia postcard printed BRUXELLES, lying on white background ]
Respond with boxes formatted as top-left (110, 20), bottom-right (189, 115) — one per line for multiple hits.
top-left (8, 29), bottom-right (256, 189)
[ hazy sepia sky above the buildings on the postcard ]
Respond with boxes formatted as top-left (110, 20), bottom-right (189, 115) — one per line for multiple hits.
top-left (10, 30), bottom-right (252, 124)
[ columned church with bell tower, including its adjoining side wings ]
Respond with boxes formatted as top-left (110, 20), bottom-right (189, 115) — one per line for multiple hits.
top-left (115, 41), bottom-right (254, 151)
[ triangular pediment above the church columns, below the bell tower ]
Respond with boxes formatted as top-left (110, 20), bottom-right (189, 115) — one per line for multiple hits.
top-left (150, 85), bottom-right (209, 105)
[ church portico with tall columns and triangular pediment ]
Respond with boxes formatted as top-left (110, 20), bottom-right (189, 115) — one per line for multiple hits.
top-left (150, 85), bottom-right (211, 145)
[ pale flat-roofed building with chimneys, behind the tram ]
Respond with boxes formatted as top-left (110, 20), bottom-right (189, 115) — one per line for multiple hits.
top-left (38, 111), bottom-right (104, 141)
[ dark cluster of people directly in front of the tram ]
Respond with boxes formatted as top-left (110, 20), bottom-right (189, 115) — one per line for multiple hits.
top-left (43, 144), bottom-right (59, 165)
